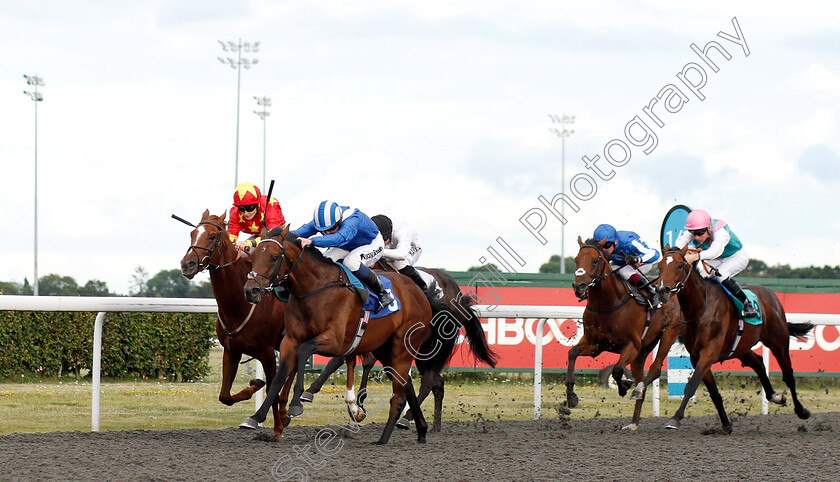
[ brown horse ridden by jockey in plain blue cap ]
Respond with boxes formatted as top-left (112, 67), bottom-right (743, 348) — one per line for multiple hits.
top-left (566, 237), bottom-right (681, 430)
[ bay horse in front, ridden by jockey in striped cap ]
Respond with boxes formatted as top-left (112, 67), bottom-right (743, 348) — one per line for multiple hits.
top-left (240, 229), bottom-right (452, 444)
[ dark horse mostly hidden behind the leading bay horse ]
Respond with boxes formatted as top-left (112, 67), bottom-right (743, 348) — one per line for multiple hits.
top-left (301, 260), bottom-right (498, 432)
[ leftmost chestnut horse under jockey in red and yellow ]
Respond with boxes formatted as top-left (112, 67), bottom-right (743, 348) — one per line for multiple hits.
top-left (181, 210), bottom-right (285, 434)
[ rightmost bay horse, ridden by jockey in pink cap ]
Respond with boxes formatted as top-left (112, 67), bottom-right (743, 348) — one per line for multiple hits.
top-left (657, 246), bottom-right (814, 434)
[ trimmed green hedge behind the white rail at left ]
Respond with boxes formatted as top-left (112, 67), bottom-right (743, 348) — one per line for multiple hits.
top-left (0, 311), bottom-right (215, 381)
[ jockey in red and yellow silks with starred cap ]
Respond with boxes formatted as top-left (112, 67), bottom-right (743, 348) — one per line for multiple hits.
top-left (228, 182), bottom-right (286, 249)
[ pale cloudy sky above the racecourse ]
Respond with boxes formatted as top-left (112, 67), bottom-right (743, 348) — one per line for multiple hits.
top-left (0, 0), bottom-right (840, 293)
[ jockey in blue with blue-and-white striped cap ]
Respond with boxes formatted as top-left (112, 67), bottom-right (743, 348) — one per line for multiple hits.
top-left (292, 201), bottom-right (394, 312)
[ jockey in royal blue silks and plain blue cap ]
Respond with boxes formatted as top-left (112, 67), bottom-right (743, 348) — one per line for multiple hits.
top-left (592, 224), bottom-right (662, 309)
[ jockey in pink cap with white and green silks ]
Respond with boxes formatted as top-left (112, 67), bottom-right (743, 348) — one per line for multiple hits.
top-left (674, 209), bottom-right (758, 318)
